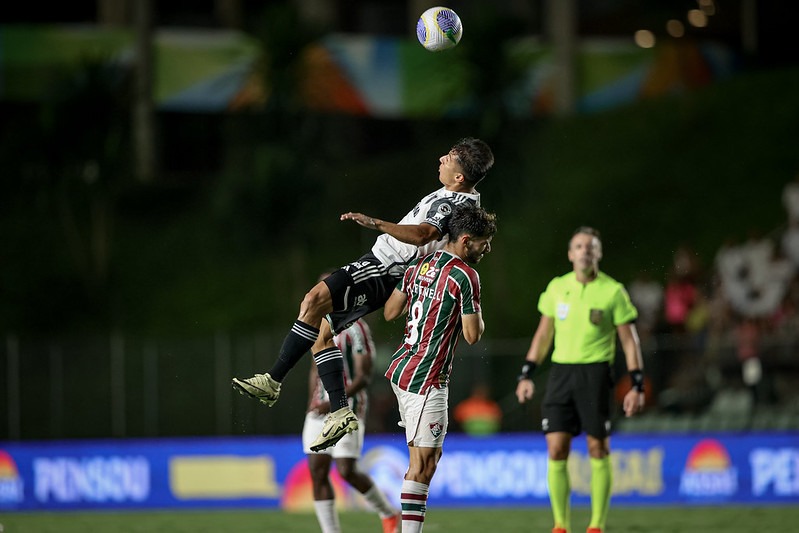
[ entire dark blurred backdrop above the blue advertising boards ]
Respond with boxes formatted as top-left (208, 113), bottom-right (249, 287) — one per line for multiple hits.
top-left (0, 0), bottom-right (799, 441)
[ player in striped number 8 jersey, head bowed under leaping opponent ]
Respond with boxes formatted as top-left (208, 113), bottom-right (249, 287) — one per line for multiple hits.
top-left (383, 204), bottom-right (497, 533)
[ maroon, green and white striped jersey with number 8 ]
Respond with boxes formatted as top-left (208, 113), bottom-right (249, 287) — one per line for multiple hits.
top-left (386, 250), bottom-right (480, 394)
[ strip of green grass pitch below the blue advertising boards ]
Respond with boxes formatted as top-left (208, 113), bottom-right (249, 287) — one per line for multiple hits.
top-left (0, 506), bottom-right (799, 533)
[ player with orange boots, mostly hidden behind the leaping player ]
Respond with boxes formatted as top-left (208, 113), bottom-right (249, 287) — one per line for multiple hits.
top-left (302, 274), bottom-right (399, 533)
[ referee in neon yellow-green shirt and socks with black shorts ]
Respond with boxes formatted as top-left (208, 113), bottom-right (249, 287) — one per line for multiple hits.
top-left (516, 226), bottom-right (644, 533)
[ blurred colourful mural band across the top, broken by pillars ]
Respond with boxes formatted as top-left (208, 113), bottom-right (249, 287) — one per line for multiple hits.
top-left (0, 26), bottom-right (735, 118)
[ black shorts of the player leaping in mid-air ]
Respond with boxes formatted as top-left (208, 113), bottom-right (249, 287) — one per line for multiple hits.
top-left (324, 253), bottom-right (401, 333)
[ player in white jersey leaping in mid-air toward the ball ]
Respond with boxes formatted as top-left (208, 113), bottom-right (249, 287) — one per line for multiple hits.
top-left (233, 137), bottom-right (494, 451)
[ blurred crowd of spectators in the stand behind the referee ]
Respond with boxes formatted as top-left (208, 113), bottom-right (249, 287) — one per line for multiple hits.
top-left (628, 175), bottom-right (799, 412)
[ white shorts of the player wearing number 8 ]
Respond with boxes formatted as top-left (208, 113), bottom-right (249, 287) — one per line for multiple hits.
top-left (391, 383), bottom-right (449, 448)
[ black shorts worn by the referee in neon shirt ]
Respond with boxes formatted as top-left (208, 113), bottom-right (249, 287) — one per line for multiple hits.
top-left (541, 363), bottom-right (613, 439)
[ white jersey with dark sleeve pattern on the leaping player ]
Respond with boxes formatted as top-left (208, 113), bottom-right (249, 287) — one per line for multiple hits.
top-left (372, 187), bottom-right (480, 278)
